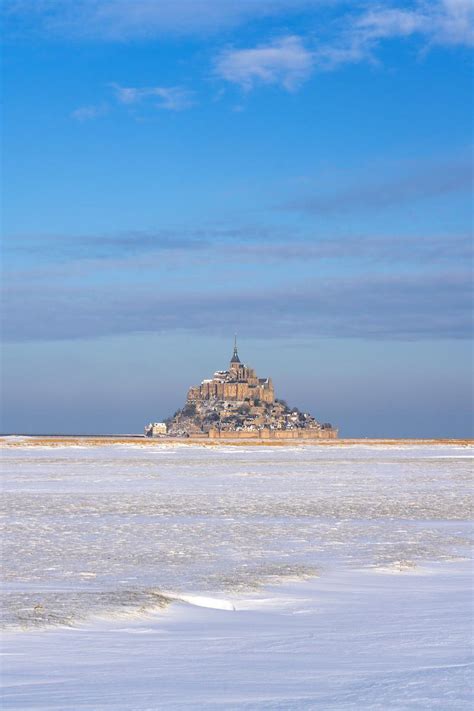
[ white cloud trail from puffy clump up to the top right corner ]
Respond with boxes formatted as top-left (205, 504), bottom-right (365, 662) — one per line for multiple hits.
top-left (215, 0), bottom-right (474, 90)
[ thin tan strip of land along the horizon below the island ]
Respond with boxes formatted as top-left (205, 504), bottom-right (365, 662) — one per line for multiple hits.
top-left (0, 435), bottom-right (474, 447)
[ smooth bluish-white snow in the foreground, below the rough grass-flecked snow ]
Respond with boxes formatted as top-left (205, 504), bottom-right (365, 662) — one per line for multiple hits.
top-left (2, 563), bottom-right (473, 711)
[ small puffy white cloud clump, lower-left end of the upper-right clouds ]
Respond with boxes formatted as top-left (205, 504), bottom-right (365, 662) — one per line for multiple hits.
top-left (215, 35), bottom-right (313, 91)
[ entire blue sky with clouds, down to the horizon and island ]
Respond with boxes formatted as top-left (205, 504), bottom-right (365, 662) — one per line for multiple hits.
top-left (2, 0), bottom-right (474, 437)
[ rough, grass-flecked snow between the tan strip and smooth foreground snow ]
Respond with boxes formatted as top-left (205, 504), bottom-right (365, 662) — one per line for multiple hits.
top-left (2, 445), bottom-right (472, 629)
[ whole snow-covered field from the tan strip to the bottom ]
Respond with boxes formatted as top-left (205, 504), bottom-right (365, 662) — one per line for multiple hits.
top-left (2, 444), bottom-right (473, 710)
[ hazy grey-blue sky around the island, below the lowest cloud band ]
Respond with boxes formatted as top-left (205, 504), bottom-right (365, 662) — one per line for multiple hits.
top-left (4, 336), bottom-right (471, 437)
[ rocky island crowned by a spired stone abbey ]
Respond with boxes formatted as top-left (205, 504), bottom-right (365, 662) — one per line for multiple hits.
top-left (145, 340), bottom-right (337, 439)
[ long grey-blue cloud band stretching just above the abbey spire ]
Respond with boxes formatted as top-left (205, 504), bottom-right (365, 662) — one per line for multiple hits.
top-left (3, 272), bottom-right (472, 341)
